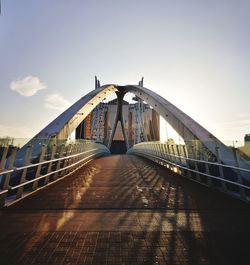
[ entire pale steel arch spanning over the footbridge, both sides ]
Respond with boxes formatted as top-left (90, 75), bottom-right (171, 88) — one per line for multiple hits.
top-left (18, 84), bottom-right (249, 171)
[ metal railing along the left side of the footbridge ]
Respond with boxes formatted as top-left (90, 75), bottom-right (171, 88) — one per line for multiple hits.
top-left (0, 142), bottom-right (110, 207)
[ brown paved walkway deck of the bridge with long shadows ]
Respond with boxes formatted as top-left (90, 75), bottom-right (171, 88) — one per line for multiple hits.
top-left (0, 155), bottom-right (250, 265)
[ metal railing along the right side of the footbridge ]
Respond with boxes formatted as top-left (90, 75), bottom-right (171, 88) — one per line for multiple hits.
top-left (128, 142), bottom-right (250, 202)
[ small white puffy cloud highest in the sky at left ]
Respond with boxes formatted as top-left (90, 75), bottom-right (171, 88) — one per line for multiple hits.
top-left (10, 75), bottom-right (46, 97)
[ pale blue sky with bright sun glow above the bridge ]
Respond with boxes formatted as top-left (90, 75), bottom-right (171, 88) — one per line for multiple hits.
top-left (0, 0), bottom-right (250, 141)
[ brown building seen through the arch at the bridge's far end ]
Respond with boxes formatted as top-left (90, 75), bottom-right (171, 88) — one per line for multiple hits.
top-left (76, 99), bottom-right (160, 146)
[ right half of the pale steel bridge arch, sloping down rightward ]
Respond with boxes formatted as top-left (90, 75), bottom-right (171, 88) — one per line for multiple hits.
top-left (123, 85), bottom-right (250, 168)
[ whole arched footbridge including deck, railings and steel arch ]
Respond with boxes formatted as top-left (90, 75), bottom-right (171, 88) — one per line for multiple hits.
top-left (0, 78), bottom-right (250, 264)
